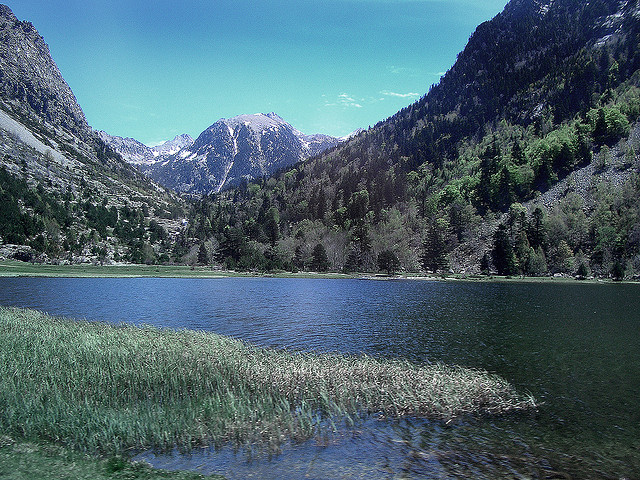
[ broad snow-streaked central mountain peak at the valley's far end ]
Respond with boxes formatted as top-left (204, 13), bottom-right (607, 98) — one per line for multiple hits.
top-left (141, 113), bottom-right (339, 193)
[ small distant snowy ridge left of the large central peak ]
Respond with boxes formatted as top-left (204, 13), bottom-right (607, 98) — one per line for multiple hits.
top-left (97, 131), bottom-right (193, 169)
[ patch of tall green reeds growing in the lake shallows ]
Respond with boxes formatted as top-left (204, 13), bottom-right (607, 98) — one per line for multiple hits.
top-left (0, 308), bottom-right (534, 454)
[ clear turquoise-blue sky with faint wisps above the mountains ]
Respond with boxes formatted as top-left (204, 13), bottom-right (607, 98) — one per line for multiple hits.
top-left (4, 0), bottom-right (507, 145)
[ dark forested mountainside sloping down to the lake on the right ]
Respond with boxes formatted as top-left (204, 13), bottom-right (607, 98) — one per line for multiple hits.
top-left (178, 0), bottom-right (640, 277)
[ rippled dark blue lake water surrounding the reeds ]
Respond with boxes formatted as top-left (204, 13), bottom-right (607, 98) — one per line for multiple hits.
top-left (0, 278), bottom-right (640, 479)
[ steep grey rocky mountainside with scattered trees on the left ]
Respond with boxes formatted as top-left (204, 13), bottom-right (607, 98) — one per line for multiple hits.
top-left (0, 5), bottom-right (184, 262)
